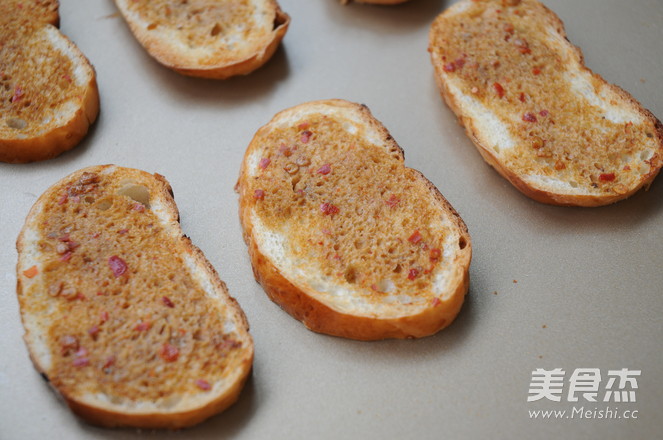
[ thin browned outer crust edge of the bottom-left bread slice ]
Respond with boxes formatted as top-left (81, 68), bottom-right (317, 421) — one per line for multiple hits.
top-left (16, 165), bottom-right (254, 429)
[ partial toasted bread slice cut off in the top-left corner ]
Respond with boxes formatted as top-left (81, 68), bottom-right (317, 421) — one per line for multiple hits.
top-left (0, 7), bottom-right (99, 163)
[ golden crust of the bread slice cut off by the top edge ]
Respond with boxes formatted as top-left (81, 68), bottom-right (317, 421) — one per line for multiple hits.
top-left (116, 0), bottom-right (290, 79)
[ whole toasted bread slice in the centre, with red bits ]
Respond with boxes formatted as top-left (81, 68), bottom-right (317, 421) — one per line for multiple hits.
top-left (238, 100), bottom-right (472, 340)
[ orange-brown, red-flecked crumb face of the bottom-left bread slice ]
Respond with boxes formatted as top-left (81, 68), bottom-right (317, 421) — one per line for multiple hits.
top-left (27, 172), bottom-right (242, 409)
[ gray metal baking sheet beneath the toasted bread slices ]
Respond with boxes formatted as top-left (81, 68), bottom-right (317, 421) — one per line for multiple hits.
top-left (0, 0), bottom-right (663, 440)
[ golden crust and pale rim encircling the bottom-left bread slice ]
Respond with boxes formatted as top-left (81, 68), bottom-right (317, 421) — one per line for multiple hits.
top-left (17, 165), bottom-right (253, 429)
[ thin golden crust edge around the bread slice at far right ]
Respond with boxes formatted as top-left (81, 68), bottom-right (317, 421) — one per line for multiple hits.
top-left (428, 0), bottom-right (663, 207)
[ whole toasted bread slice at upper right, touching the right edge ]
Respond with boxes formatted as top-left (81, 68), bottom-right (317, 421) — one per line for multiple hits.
top-left (429, 0), bottom-right (663, 206)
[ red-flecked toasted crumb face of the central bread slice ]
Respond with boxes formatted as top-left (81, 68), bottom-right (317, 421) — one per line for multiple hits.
top-left (242, 113), bottom-right (467, 306)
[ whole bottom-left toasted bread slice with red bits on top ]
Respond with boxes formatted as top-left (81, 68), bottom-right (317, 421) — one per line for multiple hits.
top-left (17, 165), bottom-right (253, 428)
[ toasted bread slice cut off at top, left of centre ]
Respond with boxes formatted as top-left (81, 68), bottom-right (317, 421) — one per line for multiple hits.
top-left (115, 0), bottom-right (290, 79)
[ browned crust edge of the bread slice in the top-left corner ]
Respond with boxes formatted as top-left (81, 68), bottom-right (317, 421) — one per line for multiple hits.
top-left (0, 24), bottom-right (99, 163)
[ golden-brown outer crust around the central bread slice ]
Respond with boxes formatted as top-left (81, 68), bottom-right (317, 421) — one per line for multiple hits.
top-left (237, 100), bottom-right (472, 341)
